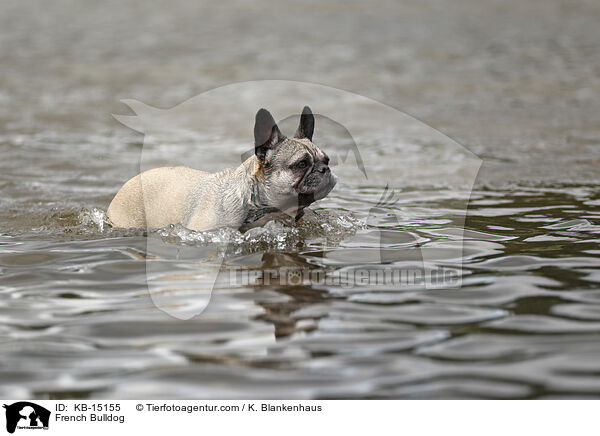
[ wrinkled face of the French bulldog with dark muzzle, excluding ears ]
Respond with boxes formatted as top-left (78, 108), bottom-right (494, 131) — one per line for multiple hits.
top-left (263, 138), bottom-right (337, 210)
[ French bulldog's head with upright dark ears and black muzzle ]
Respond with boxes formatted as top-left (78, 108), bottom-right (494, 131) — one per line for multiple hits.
top-left (254, 106), bottom-right (337, 213)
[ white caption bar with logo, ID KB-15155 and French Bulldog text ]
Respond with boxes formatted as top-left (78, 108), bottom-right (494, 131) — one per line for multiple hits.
top-left (2, 400), bottom-right (597, 436)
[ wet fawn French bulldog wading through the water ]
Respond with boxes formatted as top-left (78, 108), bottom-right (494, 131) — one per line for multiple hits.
top-left (107, 106), bottom-right (337, 231)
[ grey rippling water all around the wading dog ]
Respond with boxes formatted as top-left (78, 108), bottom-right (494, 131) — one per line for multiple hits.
top-left (0, 1), bottom-right (600, 398)
